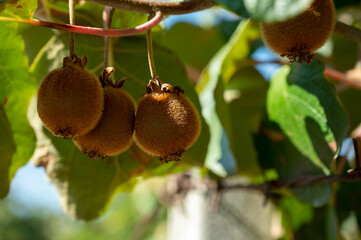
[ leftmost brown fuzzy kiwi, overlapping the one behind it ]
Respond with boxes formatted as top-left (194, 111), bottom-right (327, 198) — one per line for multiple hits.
top-left (37, 56), bottom-right (104, 139)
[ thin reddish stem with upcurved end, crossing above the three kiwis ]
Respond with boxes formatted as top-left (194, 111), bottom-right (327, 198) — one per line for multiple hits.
top-left (0, 11), bottom-right (163, 37)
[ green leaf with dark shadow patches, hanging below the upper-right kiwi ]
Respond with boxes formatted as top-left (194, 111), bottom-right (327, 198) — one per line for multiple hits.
top-left (267, 60), bottom-right (349, 173)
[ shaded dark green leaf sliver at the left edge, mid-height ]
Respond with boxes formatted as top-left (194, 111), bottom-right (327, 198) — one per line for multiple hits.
top-left (0, 105), bottom-right (16, 199)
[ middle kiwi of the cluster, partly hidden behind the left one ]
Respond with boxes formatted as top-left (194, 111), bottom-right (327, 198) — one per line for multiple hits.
top-left (74, 68), bottom-right (135, 159)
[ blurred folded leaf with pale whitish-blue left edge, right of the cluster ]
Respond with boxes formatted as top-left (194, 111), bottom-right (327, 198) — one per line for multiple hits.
top-left (197, 21), bottom-right (267, 177)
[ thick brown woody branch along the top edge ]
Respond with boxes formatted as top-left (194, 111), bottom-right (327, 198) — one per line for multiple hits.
top-left (86, 0), bottom-right (216, 15)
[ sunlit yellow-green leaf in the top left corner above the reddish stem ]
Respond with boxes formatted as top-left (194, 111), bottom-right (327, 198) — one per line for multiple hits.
top-left (0, 0), bottom-right (38, 19)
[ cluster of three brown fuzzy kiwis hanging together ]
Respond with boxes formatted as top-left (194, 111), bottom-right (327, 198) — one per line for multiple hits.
top-left (37, 56), bottom-right (200, 162)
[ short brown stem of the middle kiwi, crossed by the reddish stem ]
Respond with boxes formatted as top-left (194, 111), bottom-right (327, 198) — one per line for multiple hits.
top-left (103, 6), bottom-right (115, 69)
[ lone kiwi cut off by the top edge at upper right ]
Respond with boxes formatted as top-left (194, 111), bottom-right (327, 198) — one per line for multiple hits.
top-left (261, 0), bottom-right (335, 63)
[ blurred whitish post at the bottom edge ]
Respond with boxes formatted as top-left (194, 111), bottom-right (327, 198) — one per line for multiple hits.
top-left (167, 180), bottom-right (276, 240)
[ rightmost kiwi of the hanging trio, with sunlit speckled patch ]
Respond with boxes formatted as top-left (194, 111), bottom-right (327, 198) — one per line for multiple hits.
top-left (134, 80), bottom-right (200, 162)
